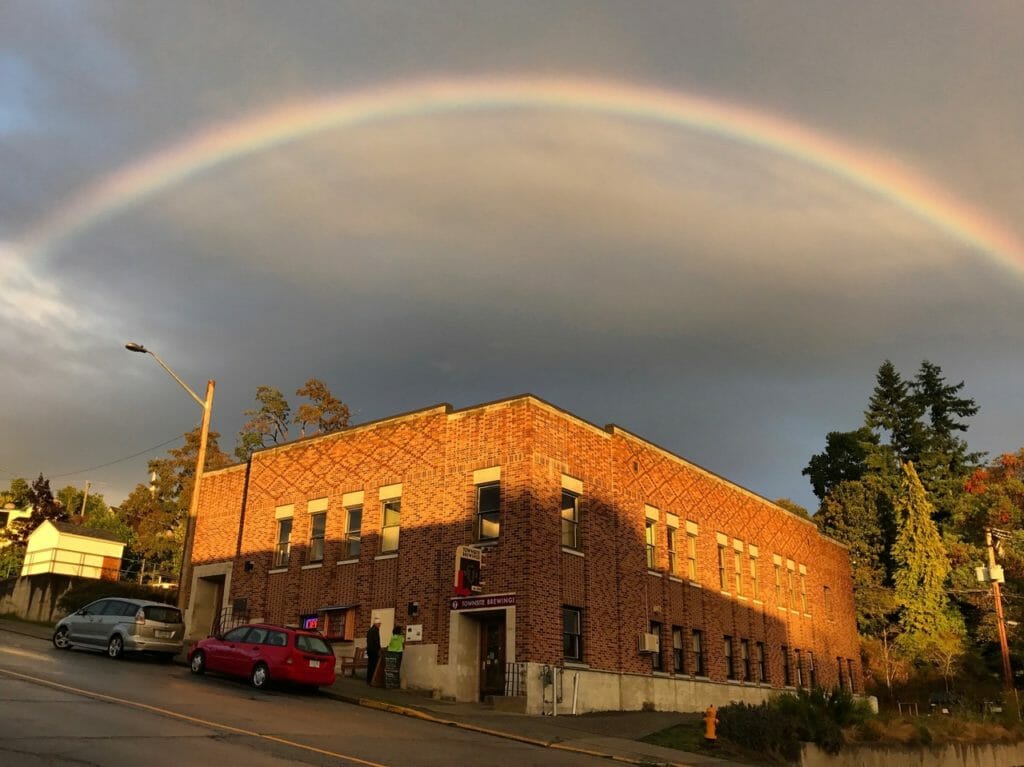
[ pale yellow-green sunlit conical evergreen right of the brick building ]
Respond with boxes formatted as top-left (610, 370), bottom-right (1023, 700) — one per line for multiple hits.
top-left (893, 463), bottom-right (964, 659)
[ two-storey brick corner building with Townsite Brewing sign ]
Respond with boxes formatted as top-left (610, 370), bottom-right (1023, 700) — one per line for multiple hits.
top-left (189, 394), bottom-right (861, 713)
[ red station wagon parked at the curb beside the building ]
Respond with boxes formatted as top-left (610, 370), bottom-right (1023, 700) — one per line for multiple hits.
top-left (188, 624), bottom-right (335, 689)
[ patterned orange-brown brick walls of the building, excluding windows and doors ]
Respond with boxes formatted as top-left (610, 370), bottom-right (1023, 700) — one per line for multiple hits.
top-left (195, 395), bottom-right (859, 686)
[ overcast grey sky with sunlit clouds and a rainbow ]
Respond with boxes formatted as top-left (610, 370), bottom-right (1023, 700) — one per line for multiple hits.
top-left (0, 0), bottom-right (1024, 508)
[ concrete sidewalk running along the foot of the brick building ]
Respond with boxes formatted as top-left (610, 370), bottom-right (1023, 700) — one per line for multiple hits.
top-left (0, 619), bottom-right (735, 767)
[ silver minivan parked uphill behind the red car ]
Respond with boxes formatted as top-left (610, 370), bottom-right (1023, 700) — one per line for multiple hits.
top-left (53, 597), bottom-right (185, 658)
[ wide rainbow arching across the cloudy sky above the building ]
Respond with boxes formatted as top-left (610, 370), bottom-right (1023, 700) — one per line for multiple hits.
top-left (17, 78), bottom-right (1024, 269)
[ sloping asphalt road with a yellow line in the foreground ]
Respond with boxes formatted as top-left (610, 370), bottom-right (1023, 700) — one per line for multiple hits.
top-left (0, 632), bottom-right (608, 767)
